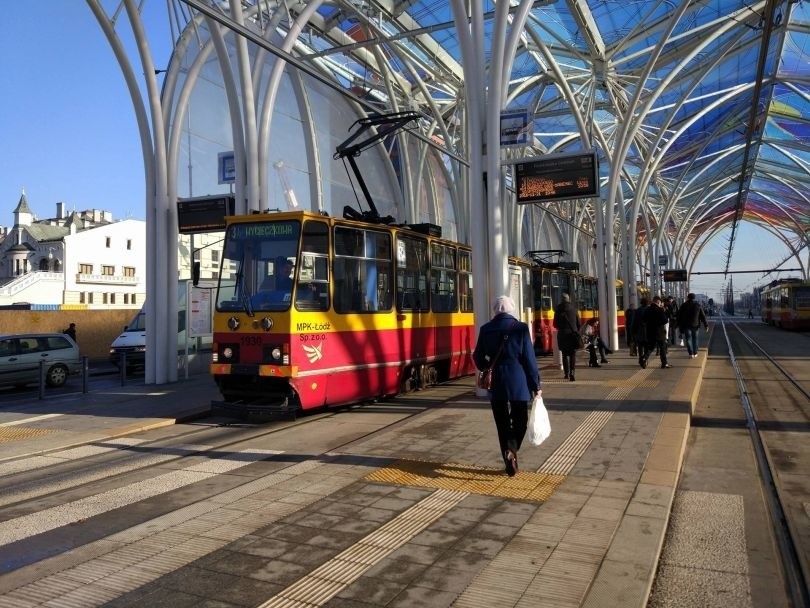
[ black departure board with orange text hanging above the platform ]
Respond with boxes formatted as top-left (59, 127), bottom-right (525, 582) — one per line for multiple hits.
top-left (515, 152), bottom-right (599, 205)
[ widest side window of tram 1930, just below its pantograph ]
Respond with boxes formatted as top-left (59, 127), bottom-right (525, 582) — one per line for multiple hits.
top-left (333, 227), bottom-right (393, 313)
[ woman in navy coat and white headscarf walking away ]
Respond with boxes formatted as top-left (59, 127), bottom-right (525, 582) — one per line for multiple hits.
top-left (473, 296), bottom-right (542, 477)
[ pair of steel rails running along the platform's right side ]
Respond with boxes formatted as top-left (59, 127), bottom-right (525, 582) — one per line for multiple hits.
top-left (719, 316), bottom-right (810, 608)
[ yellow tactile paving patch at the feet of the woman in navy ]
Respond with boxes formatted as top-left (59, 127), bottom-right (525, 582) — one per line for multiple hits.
top-left (365, 460), bottom-right (565, 502)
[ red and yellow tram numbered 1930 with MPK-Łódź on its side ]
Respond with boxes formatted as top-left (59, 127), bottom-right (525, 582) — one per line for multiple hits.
top-left (211, 211), bottom-right (476, 410)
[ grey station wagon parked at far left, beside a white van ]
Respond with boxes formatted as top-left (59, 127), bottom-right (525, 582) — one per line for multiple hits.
top-left (0, 334), bottom-right (82, 387)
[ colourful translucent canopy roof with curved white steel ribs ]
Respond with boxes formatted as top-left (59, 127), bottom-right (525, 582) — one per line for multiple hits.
top-left (183, 0), bottom-right (810, 264)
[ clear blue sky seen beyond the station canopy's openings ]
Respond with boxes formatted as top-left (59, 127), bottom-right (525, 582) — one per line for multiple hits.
top-left (0, 0), bottom-right (797, 298)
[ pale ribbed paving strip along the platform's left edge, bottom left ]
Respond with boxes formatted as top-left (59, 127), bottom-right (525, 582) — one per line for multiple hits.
top-left (0, 458), bottom-right (367, 608)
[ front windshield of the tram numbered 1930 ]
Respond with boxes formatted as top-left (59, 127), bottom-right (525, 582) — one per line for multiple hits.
top-left (217, 220), bottom-right (301, 315)
